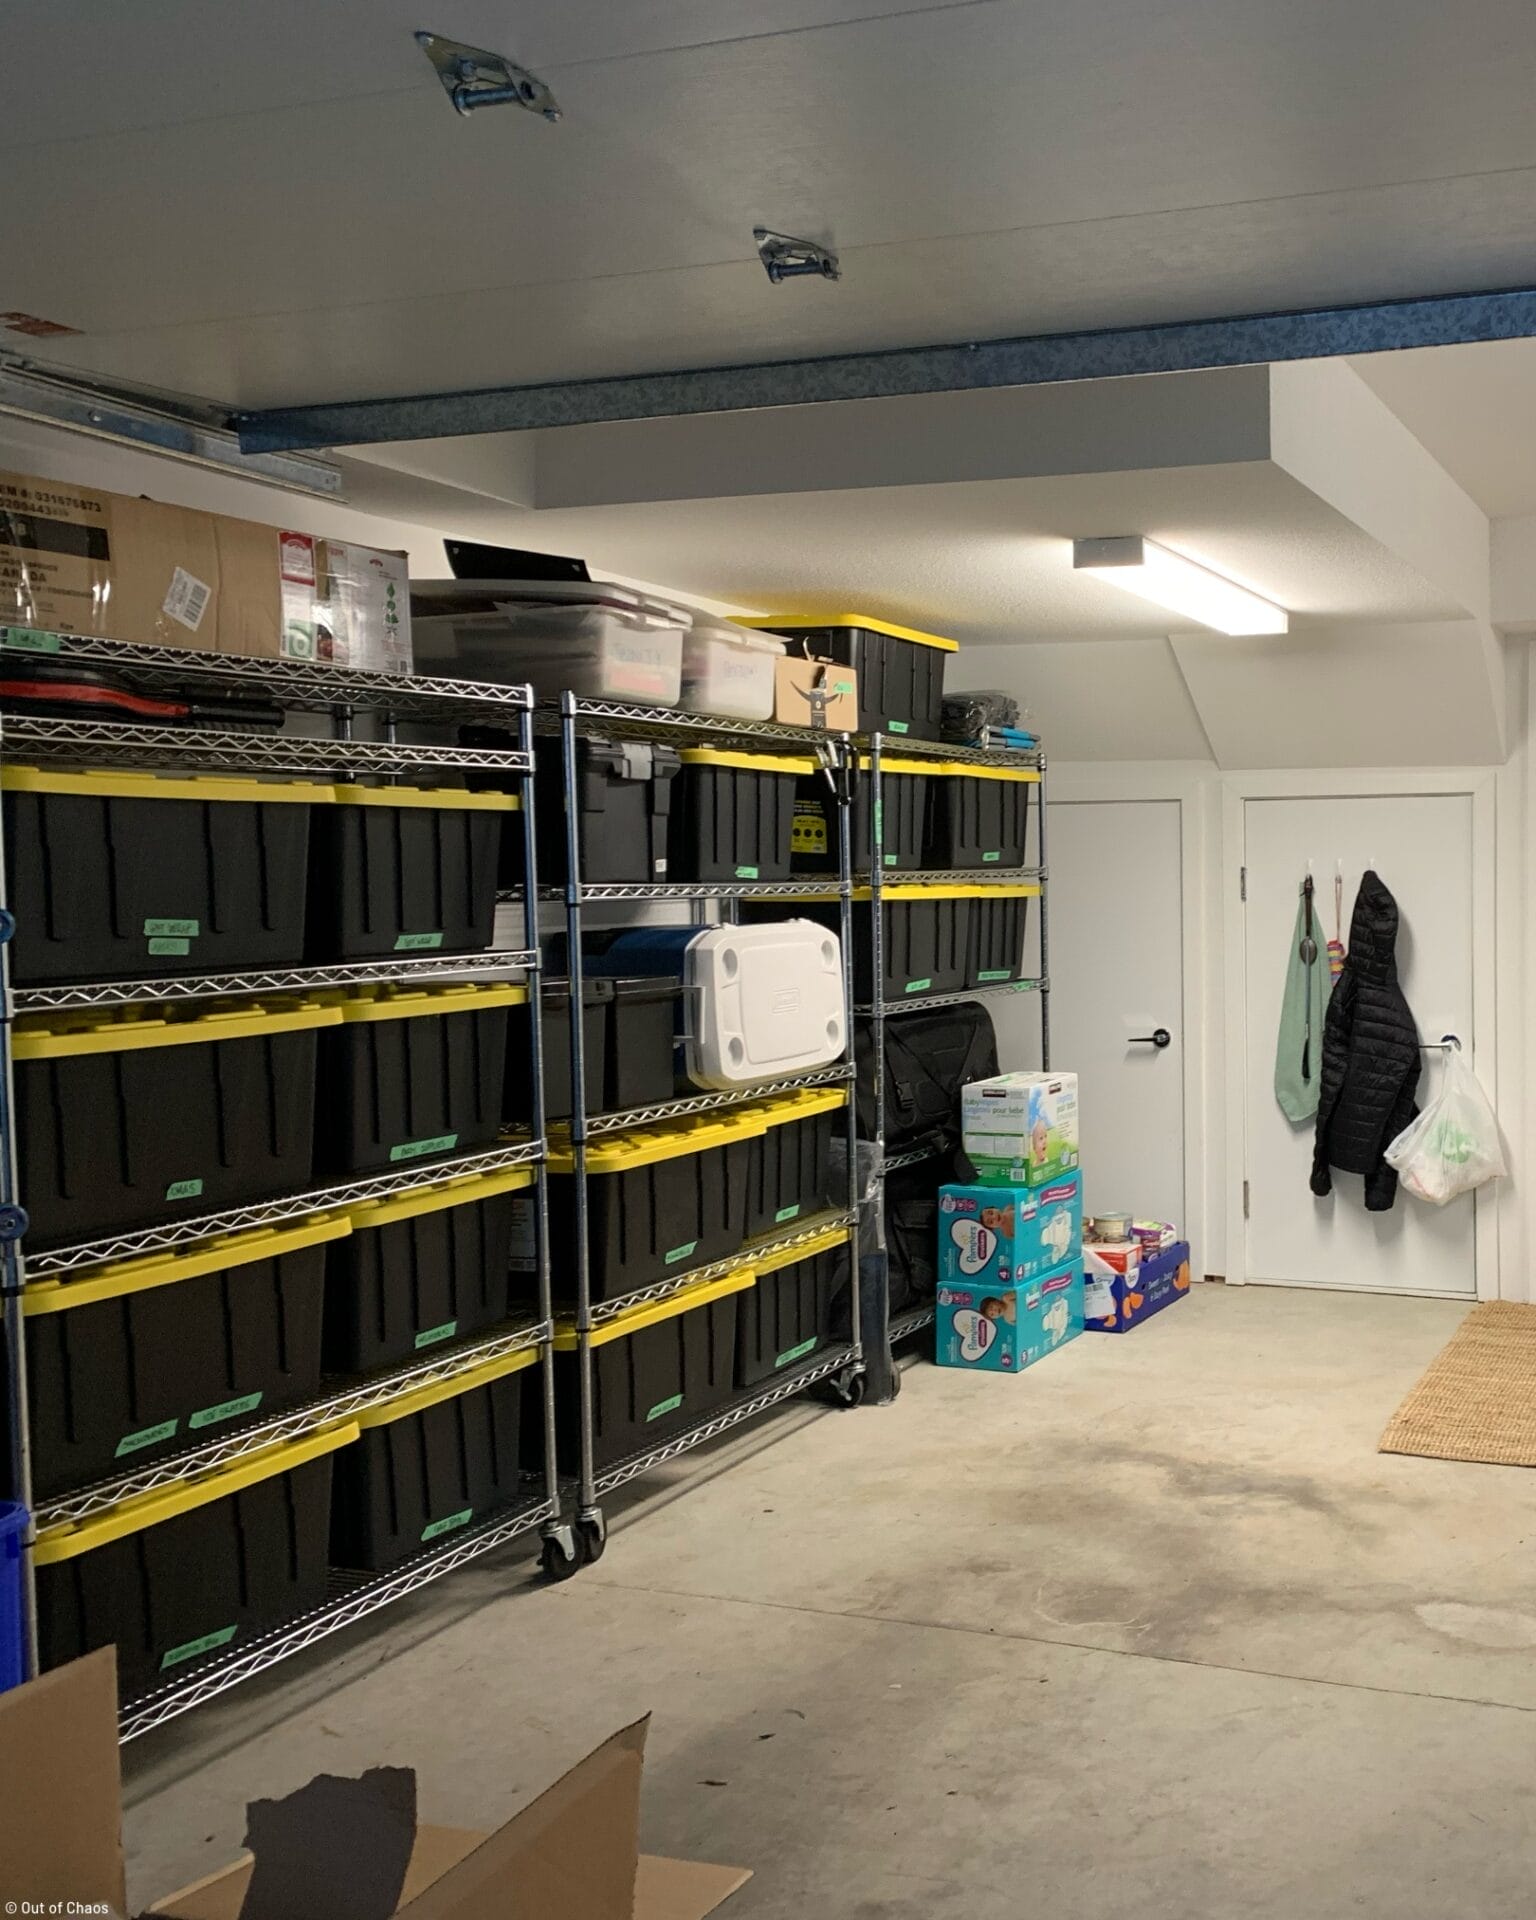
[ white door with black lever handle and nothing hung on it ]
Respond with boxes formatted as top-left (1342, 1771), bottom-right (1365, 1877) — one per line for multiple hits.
top-left (991, 801), bottom-right (1188, 1227)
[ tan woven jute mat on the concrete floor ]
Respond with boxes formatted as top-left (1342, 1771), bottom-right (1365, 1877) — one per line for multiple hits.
top-left (1380, 1300), bottom-right (1536, 1467)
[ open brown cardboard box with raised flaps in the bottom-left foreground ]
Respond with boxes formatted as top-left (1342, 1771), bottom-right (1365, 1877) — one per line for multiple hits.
top-left (0, 1647), bottom-right (751, 1920)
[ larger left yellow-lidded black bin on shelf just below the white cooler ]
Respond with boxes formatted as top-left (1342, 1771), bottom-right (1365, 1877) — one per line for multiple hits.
top-left (526, 1108), bottom-right (764, 1300)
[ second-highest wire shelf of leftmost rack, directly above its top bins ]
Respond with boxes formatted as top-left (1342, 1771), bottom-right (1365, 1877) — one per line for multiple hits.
top-left (6, 714), bottom-right (534, 776)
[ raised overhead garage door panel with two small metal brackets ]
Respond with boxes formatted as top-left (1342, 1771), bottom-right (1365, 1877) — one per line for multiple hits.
top-left (0, 0), bottom-right (1536, 407)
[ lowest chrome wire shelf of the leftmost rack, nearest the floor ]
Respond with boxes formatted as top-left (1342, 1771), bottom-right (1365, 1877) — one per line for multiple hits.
top-left (117, 1494), bottom-right (557, 1743)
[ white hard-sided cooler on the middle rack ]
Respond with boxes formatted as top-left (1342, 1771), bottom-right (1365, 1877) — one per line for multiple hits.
top-left (687, 920), bottom-right (847, 1087)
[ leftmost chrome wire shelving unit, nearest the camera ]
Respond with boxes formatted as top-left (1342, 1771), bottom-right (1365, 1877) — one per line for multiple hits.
top-left (0, 626), bottom-right (580, 1740)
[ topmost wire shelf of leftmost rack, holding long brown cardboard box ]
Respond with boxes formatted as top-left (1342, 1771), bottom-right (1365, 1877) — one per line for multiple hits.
top-left (0, 626), bottom-right (532, 724)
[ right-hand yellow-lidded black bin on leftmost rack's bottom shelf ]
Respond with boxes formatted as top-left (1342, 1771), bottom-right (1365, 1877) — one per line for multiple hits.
top-left (330, 1350), bottom-right (538, 1572)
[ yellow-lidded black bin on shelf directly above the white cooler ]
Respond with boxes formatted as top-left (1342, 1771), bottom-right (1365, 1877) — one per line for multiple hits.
top-left (666, 747), bottom-right (816, 881)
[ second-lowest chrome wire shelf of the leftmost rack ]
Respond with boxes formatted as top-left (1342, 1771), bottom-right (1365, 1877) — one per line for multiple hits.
top-left (35, 1321), bottom-right (551, 1528)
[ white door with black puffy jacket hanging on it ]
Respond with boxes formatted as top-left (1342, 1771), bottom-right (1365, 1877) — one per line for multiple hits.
top-left (1244, 793), bottom-right (1476, 1296)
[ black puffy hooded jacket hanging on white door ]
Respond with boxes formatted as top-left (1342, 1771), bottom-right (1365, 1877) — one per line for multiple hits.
top-left (1311, 874), bottom-right (1421, 1213)
